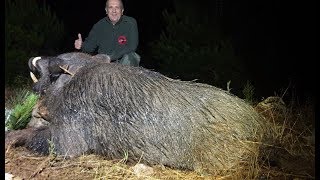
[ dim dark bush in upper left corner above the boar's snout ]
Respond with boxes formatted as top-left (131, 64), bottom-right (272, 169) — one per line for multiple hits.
top-left (5, 0), bottom-right (64, 85)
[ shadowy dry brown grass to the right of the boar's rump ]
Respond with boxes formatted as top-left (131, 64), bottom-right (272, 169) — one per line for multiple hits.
top-left (256, 97), bottom-right (315, 179)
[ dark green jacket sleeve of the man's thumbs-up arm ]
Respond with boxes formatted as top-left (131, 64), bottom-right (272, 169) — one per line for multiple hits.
top-left (81, 24), bottom-right (98, 53)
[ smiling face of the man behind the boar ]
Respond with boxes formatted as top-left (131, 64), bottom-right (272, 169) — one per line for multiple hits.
top-left (106, 0), bottom-right (123, 24)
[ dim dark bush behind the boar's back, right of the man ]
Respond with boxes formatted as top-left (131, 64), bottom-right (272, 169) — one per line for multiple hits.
top-left (151, 1), bottom-right (247, 93)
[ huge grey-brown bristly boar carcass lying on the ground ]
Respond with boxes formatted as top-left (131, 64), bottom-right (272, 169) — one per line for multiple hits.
top-left (6, 53), bottom-right (263, 172)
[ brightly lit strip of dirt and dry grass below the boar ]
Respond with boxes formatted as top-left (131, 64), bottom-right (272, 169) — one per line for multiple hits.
top-left (5, 147), bottom-right (219, 180)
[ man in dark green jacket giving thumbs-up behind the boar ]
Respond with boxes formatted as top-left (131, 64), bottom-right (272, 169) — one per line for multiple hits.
top-left (74, 0), bottom-right (140, 66)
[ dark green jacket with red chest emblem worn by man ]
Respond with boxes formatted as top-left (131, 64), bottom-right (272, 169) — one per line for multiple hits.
top-left (81, 15), bottom-right (139, 60)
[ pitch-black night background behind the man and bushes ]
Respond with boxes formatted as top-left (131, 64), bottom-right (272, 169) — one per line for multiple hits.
top-left (3, 0), bottom-right (316, 103)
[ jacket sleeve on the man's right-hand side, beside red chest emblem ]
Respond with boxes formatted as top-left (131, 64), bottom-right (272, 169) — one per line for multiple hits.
top-left (110, 19), bottom-right (139, 60)
